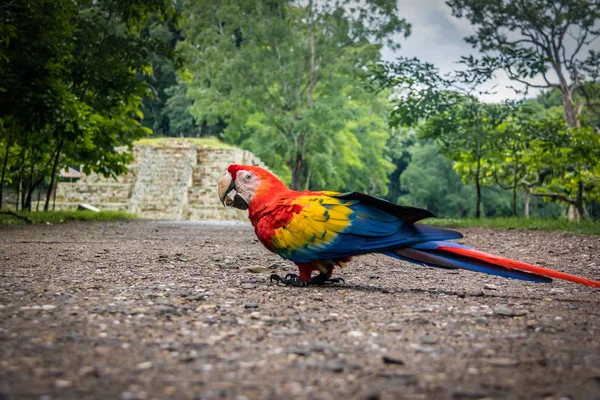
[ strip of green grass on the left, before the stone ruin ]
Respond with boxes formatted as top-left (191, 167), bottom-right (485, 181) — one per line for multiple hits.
top-left (0, 210), bottom-right (137, 225)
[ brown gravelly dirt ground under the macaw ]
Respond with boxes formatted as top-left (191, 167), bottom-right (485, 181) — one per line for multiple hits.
top-left (0, 222), bottom-right (600, 400)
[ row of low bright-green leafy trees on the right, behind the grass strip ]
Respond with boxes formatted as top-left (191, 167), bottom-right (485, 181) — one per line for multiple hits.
top-left (380, 49), bottom-right (600, 218)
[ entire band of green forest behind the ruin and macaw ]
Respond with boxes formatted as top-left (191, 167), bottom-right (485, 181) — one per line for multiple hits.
top-left (0, 0), bottom-right (600, 219)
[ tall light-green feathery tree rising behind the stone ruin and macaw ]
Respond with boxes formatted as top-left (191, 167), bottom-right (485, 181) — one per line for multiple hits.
top-left (181, 0), bottom-right (410, 189)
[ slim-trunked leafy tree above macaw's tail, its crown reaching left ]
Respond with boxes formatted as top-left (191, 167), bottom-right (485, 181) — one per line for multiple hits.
top-left (372, 58), bottom-right (513, 218)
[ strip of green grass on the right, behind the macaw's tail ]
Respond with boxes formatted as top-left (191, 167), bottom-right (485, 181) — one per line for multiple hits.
top-left (424, 218), bottom-right (600, 236)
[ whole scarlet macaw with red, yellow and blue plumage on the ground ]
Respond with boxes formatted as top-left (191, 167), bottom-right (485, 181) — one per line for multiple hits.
top-left (219, 164), bottom-right (600, 288)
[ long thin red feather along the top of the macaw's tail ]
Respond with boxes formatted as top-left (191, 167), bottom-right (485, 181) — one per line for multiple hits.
top-left (437, 246), bottom-right (600, 288)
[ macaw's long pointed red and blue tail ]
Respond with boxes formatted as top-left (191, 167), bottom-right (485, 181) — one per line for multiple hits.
top-left (386, 241), bottom-right (600, 288)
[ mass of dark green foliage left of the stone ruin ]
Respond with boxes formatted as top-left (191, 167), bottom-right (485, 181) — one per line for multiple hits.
top-left (0, 0), bottom-right (178, 208)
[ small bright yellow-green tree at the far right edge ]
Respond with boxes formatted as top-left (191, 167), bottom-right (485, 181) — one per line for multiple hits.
top-left (519, 90), bottom-right (599, 219)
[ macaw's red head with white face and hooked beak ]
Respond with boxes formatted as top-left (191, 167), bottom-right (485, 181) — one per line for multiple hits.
top-left (219, 164), bottom-right (287, 210)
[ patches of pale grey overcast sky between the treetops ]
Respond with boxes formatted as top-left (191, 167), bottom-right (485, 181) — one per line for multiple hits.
top-left (383, 0), bottom-right (537, 102)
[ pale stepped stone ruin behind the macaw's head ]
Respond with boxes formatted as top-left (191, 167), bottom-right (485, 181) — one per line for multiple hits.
top-left (56, 139), bottom-right (263, 220)
